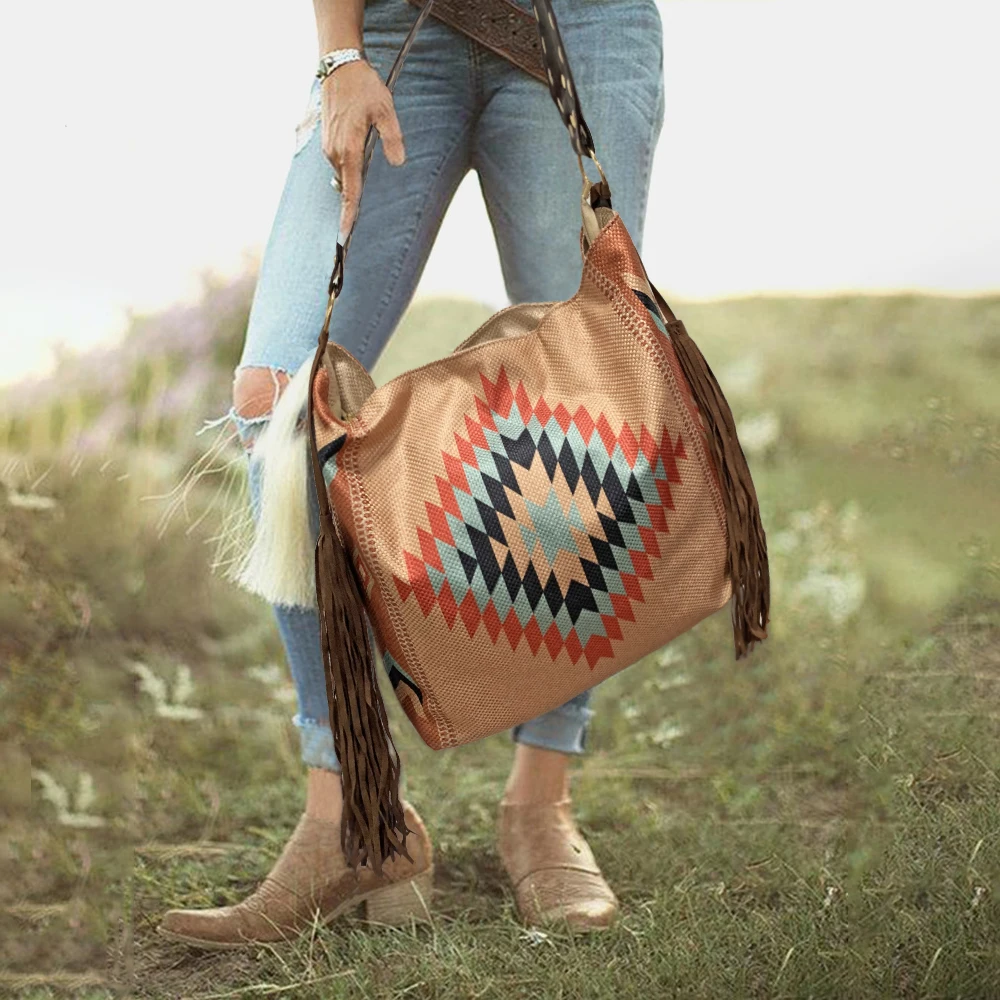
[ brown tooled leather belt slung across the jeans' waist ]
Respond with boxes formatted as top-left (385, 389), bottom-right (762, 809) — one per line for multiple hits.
top-left (407, 0), bottom-right (549, 84)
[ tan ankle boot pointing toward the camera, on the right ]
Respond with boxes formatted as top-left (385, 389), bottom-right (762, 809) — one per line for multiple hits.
top-left (497, 798), bottom-right (618, 930)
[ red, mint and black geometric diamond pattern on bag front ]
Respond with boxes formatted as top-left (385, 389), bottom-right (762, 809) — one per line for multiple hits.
top-left (386, 352), bottom-right (688, 669)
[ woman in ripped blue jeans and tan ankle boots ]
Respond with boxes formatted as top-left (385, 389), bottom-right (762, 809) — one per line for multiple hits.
top-left (160, 0), bottom-right (663, 947)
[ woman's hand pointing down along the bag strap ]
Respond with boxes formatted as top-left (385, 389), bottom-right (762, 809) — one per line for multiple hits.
top-left (322, 60), bottom-right (406, 238)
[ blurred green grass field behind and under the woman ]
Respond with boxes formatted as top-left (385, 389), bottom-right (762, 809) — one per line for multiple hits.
top-left (0, 286), bottom-right (1000, 1000)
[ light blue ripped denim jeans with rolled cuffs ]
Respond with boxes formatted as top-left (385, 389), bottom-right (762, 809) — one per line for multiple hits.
top-left (230, 0), bottom-right (664, 771)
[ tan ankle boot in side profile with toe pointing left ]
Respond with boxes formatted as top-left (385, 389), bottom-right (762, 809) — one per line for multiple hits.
top-left (157, 803), bottom-right (434, 948)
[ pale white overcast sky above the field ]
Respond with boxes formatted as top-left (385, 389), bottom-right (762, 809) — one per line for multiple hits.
top-left (0, 0), bottom-right (1000, 383)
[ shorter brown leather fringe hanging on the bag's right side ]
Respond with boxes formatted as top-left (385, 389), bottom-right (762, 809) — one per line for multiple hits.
top-left (647, 275), bottom-right (771, 660)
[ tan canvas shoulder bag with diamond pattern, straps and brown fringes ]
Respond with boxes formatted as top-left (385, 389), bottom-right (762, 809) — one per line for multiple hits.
top-left (300, 0), bottom-right (769, 870)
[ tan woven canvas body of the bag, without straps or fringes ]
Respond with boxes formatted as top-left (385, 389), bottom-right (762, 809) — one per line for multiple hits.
top-left (314, 213), bottom-right (732, 749)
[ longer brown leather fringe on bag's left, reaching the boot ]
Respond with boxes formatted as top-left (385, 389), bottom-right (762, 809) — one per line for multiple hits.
top-left (308, 330), bottom-right (413, 874)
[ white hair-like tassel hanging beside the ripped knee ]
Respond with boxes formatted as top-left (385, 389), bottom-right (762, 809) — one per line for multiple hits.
top-left (232, 357), bottom-right (316, 607)
